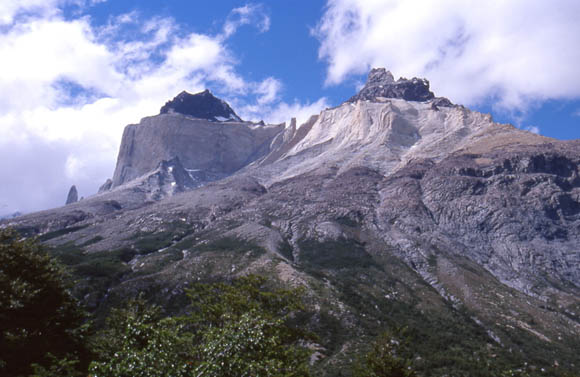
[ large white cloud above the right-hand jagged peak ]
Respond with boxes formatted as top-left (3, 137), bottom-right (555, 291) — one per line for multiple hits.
top-left (313, 0), bottom-right (580, 112)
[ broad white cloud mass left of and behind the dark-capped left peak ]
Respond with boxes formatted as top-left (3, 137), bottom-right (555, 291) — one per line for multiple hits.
top-left (0, 0), bottom-right (322, 214)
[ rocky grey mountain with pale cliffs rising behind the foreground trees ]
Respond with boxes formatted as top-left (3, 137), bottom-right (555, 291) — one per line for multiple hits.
top-left (2, 69), bottom-right (580, 376)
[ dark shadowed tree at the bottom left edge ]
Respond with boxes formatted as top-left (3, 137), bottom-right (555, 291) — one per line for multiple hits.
top-left (0, 229), bottom-right (89, 376)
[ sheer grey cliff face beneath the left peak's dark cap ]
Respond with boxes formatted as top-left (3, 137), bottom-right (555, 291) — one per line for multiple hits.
top-left (111, 103), bottom-right (284, 188)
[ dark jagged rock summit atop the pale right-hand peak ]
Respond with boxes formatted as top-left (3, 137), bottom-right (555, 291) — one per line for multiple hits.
top-left (347, 68), bottom-right (451, 106)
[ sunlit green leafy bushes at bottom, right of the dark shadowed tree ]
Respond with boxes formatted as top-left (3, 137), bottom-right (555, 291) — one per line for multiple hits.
top-left (89, 276), bottom-right (310, 377)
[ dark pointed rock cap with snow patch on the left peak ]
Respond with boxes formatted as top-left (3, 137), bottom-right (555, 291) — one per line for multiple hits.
top-left (160, 89), bottom-right (242, 122)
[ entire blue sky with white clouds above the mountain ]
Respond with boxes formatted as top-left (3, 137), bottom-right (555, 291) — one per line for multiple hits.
top-left (0, 0), bottom-right (580, 215)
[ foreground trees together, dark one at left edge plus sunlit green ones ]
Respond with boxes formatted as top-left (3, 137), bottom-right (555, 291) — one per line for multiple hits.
top-left (0, 230), bottom-right (314, 377)
